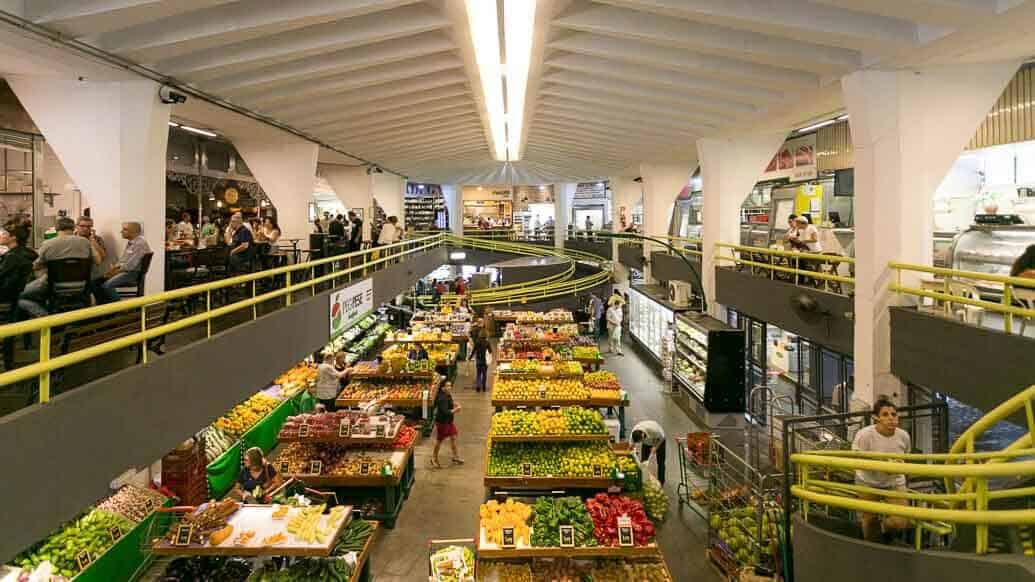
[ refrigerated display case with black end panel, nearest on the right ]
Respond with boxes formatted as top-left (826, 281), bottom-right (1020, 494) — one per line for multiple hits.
top-left (675, 313), bottom-right (745, 412)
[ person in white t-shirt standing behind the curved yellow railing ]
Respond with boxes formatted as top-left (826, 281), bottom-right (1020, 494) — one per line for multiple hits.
top-left (852, 396), bottom-right (912, 542)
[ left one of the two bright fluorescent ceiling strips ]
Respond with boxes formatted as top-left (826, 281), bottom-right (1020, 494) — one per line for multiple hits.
top-left (466, 0), bottom-right (507, 162)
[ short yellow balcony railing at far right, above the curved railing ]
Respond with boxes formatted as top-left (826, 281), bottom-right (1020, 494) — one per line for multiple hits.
top-left (888, 263), bottom-right (1035, 333)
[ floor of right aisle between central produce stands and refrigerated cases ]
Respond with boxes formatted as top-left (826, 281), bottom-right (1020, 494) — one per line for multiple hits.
top-left (601, 339), bottom-right (719, 582)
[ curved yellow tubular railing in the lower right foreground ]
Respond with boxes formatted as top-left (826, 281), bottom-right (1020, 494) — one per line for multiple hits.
top-left (791, 385), bottom-right (1035, 554)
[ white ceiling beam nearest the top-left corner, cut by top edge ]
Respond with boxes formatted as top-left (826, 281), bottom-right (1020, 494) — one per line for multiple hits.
top-left (25, 0), bottom-right (238, 38)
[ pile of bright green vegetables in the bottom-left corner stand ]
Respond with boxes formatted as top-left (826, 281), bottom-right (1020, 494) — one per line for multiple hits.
top-left (14, 510), bottom-right (134, 578)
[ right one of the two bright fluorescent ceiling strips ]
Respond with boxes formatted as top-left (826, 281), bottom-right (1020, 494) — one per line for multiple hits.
top-left (503, 0), bottom-right (535, 162)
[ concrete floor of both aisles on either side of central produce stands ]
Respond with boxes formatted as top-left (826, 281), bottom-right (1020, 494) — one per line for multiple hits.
top-left (373, 333), bottom-right (719, 582)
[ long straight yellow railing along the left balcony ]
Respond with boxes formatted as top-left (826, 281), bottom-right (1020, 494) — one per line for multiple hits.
top-left (0, 235), bottom-right (445, 403)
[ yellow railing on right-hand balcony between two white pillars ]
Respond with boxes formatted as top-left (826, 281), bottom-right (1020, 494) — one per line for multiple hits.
top-left (715, 242), bottom-right (855, 293)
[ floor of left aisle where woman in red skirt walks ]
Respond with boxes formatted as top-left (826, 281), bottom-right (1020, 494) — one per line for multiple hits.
top-left (372, 361), bottom-right (495, 582)
